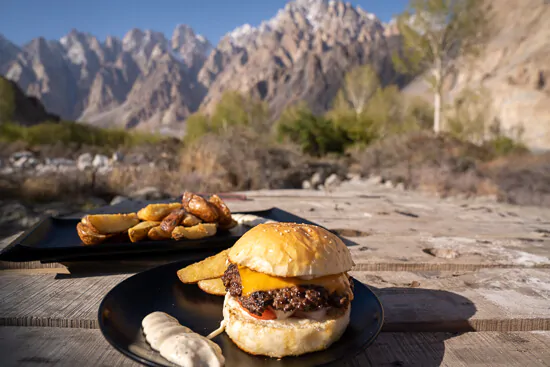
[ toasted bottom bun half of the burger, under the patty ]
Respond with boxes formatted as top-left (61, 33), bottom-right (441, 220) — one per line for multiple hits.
top-left (223, 294), bottom-right (351, 358)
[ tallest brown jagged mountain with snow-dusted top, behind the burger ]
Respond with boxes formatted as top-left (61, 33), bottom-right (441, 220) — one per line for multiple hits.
top-left (199, 0), bottom-right (395, 113)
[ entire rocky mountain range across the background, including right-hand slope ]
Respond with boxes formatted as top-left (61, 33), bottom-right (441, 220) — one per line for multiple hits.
top-left (0, 0), bottom-right (550, 148)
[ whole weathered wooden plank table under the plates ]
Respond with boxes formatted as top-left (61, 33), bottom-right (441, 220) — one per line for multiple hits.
top-left (0, 182), bottom-right (550, 367)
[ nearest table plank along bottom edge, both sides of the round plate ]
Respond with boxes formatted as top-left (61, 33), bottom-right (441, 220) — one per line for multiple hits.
top-left (0, 327), bottom-right (550, 367)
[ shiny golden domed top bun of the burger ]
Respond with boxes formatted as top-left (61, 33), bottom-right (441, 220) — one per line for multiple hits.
top-left (228, 223), bottom-right (354, 277)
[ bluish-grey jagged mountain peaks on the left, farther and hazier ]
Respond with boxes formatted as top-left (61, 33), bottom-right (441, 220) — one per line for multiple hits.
top-left (0, 26), bottom-right (211, 127)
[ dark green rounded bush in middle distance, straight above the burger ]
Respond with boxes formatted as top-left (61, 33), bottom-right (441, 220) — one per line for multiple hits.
top-left (276, 104), bottom-right (351, 156)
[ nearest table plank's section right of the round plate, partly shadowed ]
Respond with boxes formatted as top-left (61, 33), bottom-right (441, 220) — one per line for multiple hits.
top-left (348, 332), bottom-right (550, 367)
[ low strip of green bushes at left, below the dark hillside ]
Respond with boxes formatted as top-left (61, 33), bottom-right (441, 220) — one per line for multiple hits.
top-left (0, 121), bottom-right (162, 149)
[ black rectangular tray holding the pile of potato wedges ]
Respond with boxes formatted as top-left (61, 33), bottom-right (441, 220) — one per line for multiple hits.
top-left (0, 207), bottom-right (322, 262)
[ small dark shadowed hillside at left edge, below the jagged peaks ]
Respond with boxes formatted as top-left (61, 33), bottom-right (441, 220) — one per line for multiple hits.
top-left (0, 76), bottom-right (59, 126)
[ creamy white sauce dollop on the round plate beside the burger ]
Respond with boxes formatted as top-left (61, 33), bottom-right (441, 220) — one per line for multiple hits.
top-left (141, 312), bottom-right (229, 367)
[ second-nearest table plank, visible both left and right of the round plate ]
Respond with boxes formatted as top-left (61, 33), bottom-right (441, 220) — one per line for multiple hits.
top-left (0, 269), bottom-right (550, 331)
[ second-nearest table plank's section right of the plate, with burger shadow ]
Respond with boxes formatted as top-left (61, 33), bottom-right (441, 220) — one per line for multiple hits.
top-left (351, 269), bottom-right (550, 331)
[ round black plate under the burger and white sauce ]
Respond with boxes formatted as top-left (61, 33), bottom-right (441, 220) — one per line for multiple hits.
top-left (98, 261), bottom-right (384, 367)
